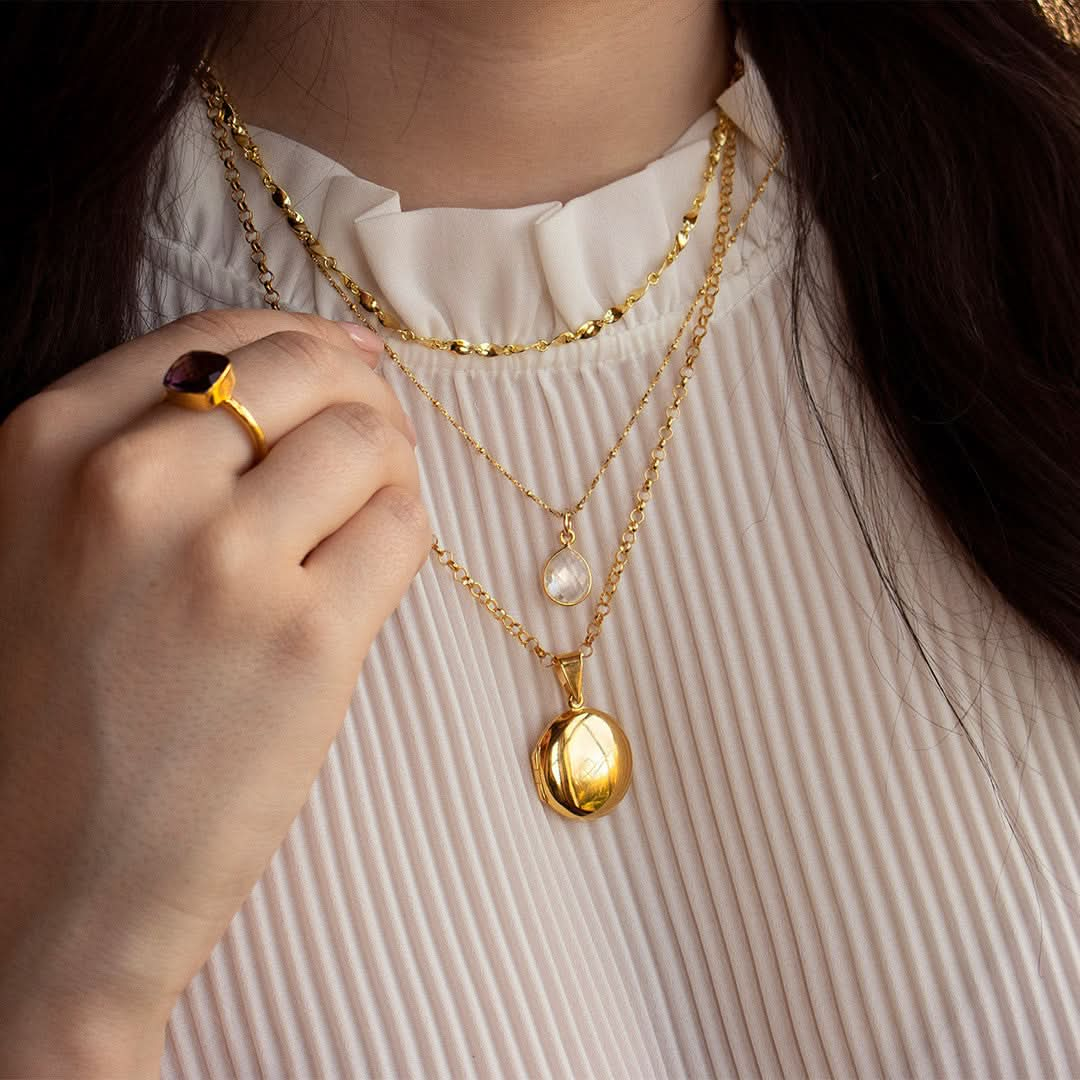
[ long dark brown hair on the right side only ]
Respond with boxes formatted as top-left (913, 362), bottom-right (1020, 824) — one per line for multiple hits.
top-left (731, 0), bottom-right (1080, 660)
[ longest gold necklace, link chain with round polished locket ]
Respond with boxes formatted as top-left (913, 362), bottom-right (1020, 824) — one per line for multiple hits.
top-left (198, 65), bottom-right (783, 821)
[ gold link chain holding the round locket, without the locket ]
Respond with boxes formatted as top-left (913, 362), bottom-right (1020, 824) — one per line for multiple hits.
top-left (200, 68), bottom-right (784, 666)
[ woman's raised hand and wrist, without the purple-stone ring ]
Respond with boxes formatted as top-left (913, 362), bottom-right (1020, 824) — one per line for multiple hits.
top-left (0, 311), bottom-right (431, 1076)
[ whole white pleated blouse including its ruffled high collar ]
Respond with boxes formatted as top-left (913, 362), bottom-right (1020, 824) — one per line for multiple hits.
top-left (145, 31), bottom-right (1080, 1080)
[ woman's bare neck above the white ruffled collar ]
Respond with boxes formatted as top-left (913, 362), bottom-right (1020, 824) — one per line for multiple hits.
top-left (214, 0), bottom-right (733, 210)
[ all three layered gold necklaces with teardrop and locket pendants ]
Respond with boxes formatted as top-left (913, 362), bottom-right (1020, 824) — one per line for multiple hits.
top-left (197, 59), bottom-right (783, 820)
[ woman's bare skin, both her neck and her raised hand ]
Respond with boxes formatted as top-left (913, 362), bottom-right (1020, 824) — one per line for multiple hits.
top-left (0, 0), bottom-right (730, 1078)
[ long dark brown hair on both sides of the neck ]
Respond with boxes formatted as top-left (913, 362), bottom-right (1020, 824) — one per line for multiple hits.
top-left (0, 0), bottom-right (1080, 738)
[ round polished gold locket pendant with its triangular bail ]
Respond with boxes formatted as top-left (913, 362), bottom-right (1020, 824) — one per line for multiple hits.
top-left (531, 652), bottom-right (634, 820)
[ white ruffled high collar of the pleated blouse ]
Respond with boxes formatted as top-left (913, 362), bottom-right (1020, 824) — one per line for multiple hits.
top-left (179, 24), bottom-right (784, 368)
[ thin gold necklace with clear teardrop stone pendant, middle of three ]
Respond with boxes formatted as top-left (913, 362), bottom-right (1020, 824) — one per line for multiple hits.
top-left (197, 65), bottom-right (772, 607)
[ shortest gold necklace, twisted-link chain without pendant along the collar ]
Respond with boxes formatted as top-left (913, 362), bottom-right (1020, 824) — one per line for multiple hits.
top-left (197, 58), bottom-right (743, 356)
